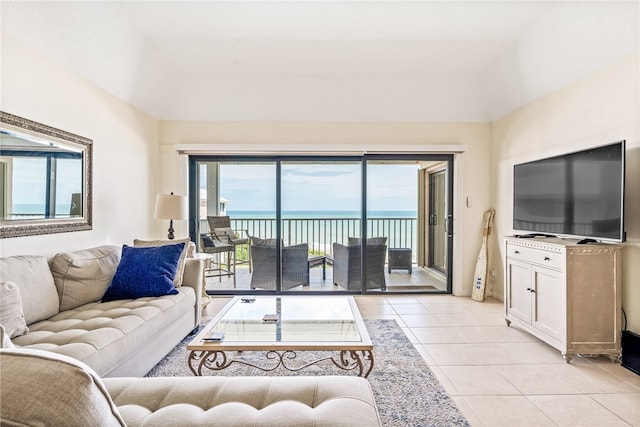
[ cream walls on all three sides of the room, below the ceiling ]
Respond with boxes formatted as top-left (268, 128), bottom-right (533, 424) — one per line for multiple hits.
top-left (0, 29), bottom-right (640, 314)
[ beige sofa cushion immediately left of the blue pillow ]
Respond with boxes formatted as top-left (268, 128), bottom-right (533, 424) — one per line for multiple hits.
top-left (49, 245), bottom-right (122, 311)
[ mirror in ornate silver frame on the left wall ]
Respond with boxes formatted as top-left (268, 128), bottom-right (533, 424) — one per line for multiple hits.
top-left (0, 111), bottom-right (93, 238)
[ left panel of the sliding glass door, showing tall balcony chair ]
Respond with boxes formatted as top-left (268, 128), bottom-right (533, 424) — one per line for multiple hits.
top-left (190, 160), bottom-right (277, 292)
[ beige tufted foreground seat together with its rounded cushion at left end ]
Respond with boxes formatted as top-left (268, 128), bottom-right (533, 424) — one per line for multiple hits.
top-left (0, 349), bottom-right (381, 427)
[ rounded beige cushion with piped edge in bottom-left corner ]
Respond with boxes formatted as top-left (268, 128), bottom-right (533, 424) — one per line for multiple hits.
top-left (0, 348), bottom-right (125, 427)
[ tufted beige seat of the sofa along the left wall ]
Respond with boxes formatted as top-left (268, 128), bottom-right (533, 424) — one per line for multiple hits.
top-left (13, 286), bottom-right (196, 376)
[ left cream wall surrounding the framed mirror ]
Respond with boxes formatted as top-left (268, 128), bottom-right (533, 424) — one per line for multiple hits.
top-left (0, 34), bottom-right (158, 256)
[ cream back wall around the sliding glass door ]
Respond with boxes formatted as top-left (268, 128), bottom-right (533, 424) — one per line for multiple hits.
top-left (160, 122), bottom-right (492, 295)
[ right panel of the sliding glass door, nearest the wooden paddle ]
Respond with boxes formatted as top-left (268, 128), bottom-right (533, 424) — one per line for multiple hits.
top-left (365, 155), bottom-right (453, 292)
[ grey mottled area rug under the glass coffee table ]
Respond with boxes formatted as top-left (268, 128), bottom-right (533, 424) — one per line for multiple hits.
top-left (147, 320), bottom-right (469, 427)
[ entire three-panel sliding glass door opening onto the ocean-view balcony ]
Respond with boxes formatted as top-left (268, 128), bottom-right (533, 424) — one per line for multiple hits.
top-left (189, 155), bottom-right (453, 293)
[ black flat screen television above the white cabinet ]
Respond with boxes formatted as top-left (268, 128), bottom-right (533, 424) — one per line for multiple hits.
top-left (513, 141), bottom-right (625, 242)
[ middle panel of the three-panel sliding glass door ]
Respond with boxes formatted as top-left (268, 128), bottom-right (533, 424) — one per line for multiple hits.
top-left (280, 158), bottom-right (362, 292)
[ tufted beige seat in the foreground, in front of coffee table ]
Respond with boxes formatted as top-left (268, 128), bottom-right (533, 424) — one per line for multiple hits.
top-left (104, 376), bottom-right (381, 427)
